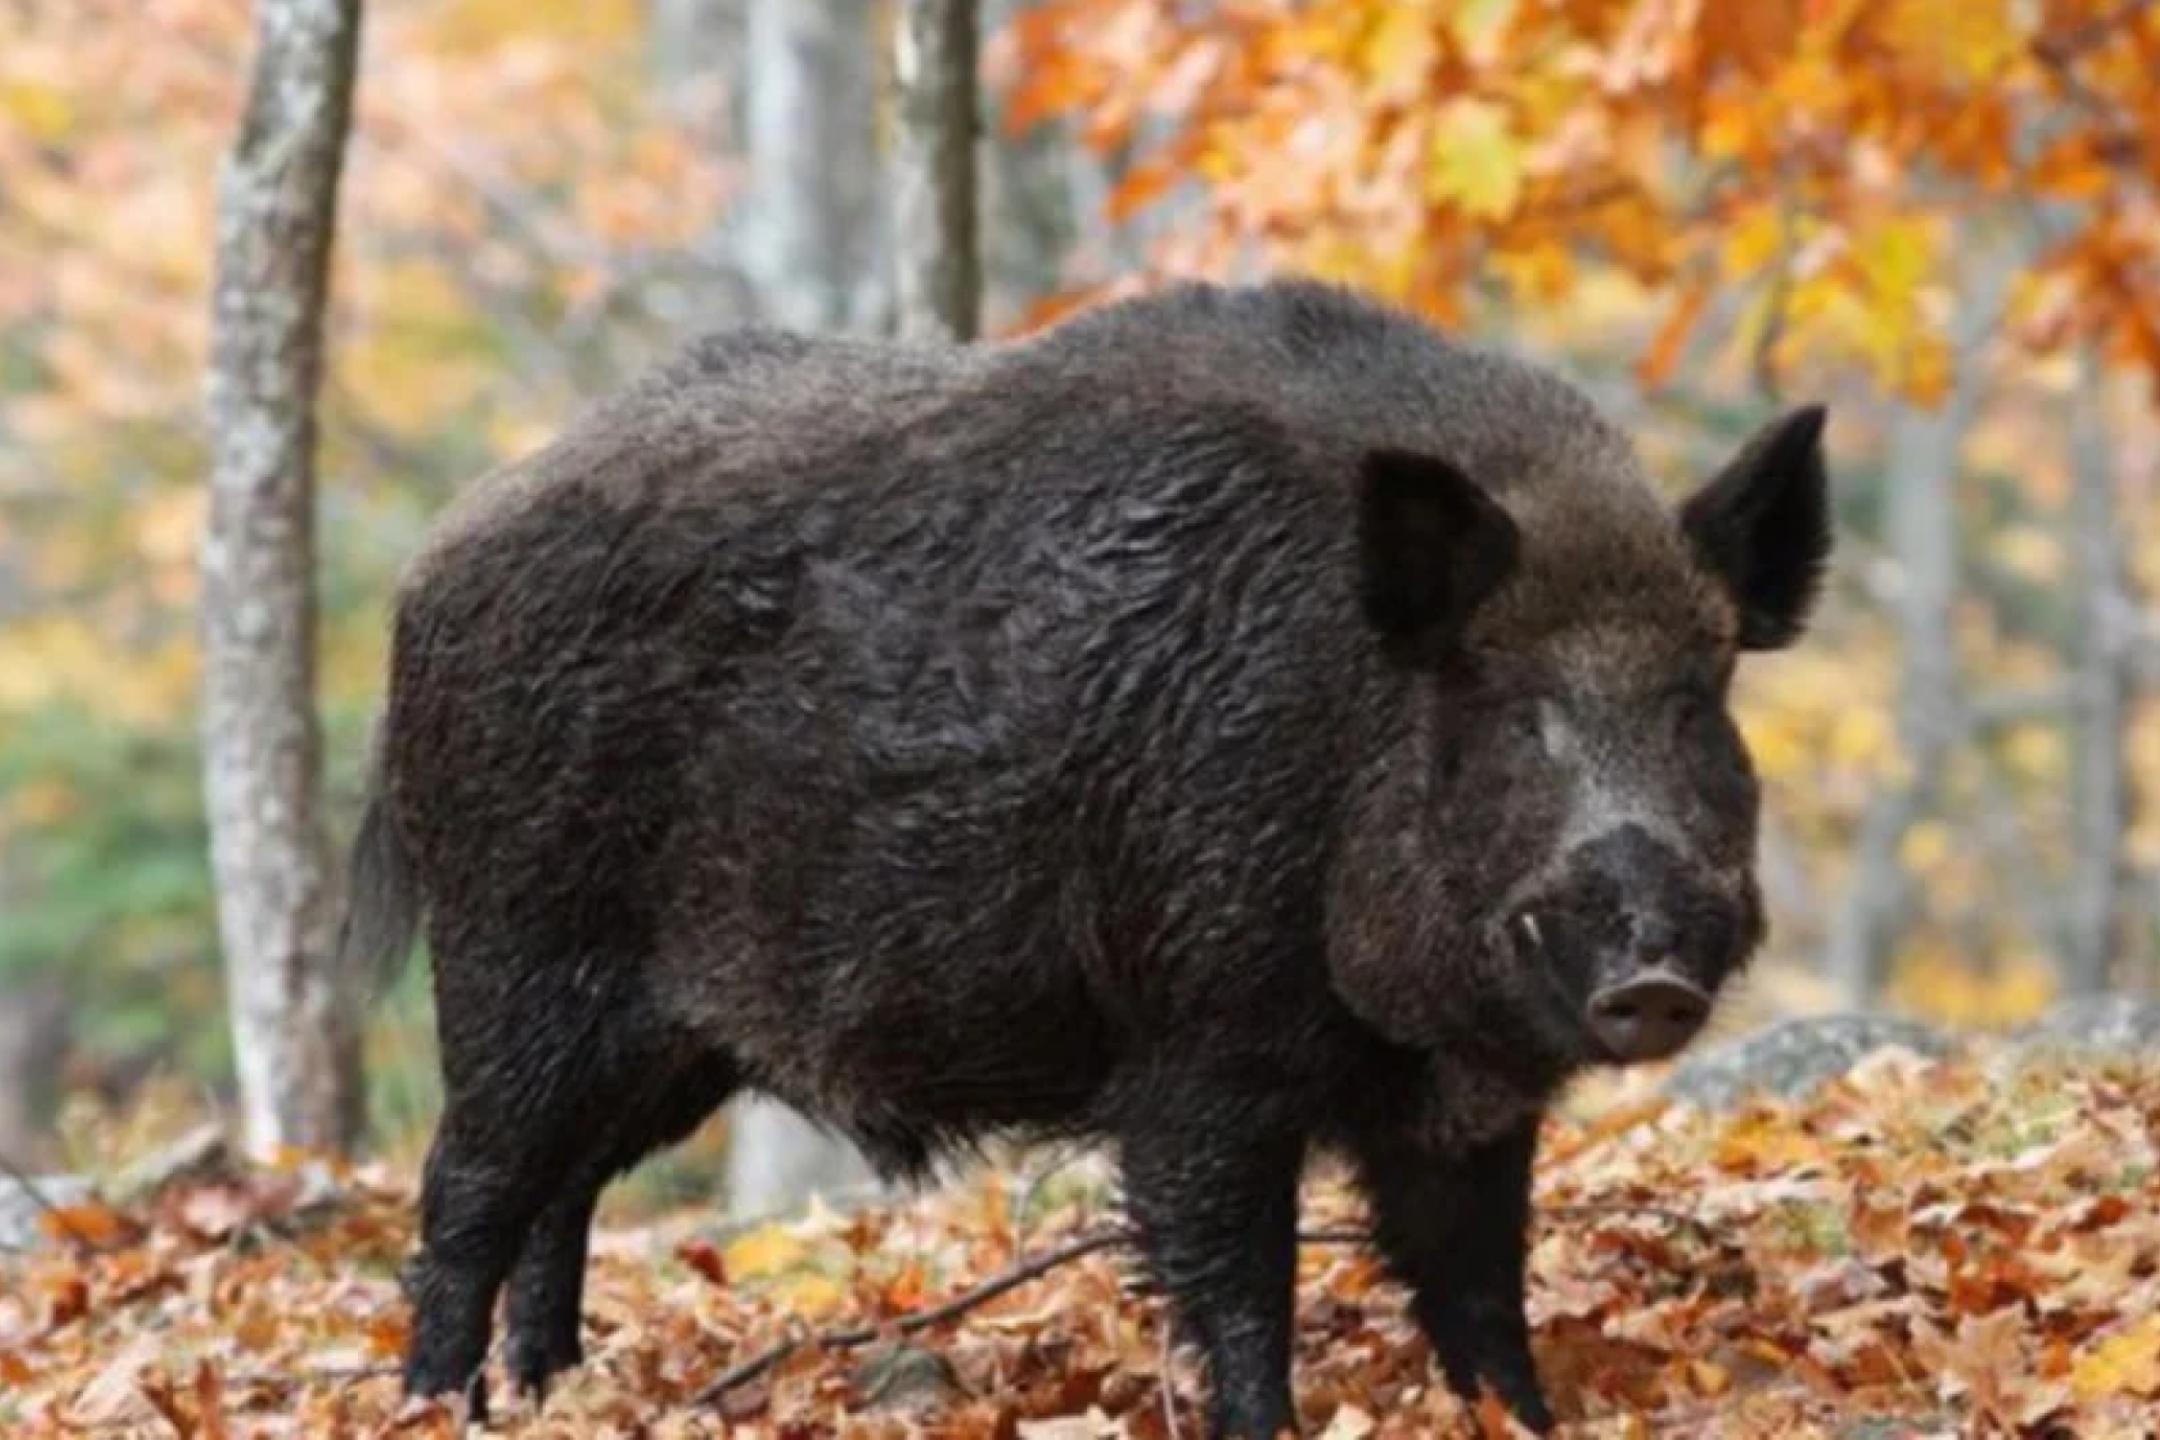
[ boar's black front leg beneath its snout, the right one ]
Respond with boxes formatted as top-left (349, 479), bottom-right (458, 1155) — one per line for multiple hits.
top-left (1359, 1125), bottom-right (1553, 1431)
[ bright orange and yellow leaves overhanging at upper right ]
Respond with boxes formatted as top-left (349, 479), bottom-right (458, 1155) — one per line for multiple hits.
top-left (1007, 0), bottom-right (2160, 399)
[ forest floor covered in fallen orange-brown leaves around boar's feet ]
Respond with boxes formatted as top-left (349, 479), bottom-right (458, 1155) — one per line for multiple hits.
top-left (0, 1051), bottom-right (2160, 1440)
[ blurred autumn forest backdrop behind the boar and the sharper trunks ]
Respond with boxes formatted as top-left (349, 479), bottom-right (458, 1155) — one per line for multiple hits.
top-left (0, 0), bottom-right (2160, 1200)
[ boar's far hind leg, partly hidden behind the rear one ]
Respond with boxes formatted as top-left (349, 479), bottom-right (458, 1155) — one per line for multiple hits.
top-left (508, 1058), bottom-right (737, 1397)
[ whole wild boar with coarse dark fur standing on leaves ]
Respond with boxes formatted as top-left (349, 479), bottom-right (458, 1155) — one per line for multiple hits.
top-left (352, 283), bottom-right (1827, 1436)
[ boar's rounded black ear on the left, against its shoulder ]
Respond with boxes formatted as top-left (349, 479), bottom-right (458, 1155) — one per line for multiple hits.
top-left (1359, 449), bottom-right (1523, 658)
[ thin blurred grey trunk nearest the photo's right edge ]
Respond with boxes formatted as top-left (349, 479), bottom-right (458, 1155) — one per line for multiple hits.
top-left (2063, 354), bottom-right (2136, 995)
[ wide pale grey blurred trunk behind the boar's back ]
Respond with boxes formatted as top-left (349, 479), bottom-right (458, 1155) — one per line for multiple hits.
top-left (737, 0), bottom-right (888, 330)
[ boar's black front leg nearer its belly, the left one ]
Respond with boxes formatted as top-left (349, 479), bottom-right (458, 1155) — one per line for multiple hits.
top-left (1121, 1101), bottom-right (1305, 1440)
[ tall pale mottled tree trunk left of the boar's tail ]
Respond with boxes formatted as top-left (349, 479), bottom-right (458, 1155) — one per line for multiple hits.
top-left (203, 0), bottom-right (361, 1153)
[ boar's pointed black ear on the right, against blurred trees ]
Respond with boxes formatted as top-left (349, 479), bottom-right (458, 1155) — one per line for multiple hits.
top-left (1680, 406), bottom-right (1830, 650)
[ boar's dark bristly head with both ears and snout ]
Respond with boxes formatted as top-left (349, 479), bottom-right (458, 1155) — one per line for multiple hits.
top-left (1331, 408), bottom-right (1830, 1073)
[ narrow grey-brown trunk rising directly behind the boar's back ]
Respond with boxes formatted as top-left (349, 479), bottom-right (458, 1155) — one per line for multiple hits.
top-left (894, 0), bottom-right (983, 341)
